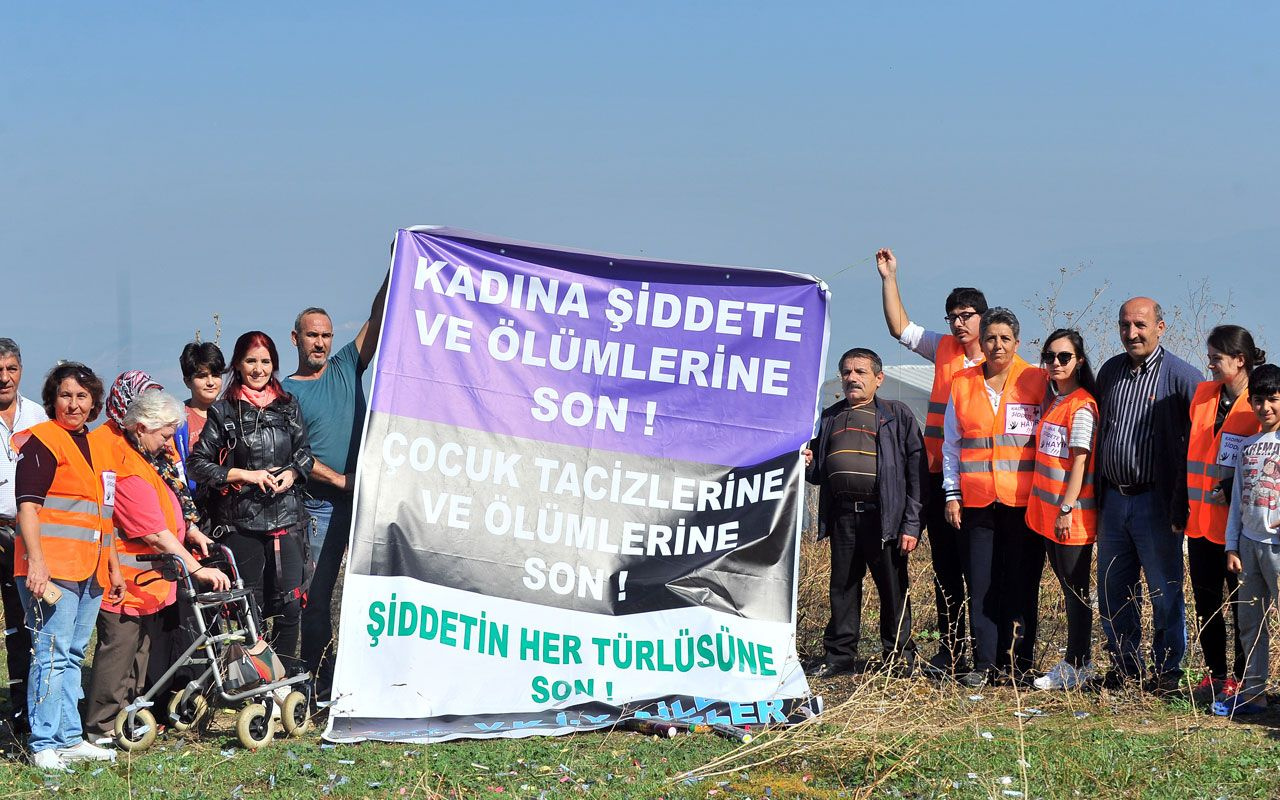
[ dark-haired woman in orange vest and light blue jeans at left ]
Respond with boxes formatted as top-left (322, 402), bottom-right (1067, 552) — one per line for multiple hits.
top-left (13, 361), bottom-right (124, 772)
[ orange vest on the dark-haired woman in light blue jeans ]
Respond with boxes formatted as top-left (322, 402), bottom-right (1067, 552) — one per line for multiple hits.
top-left (13, 420), bottom-right (115, 588)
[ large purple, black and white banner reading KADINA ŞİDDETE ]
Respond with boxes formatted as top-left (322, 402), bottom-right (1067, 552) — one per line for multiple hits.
top-left (326, 228), bottom-right (828, 741)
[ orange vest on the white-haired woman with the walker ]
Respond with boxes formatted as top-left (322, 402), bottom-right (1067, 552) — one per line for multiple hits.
top-left (102, 422), bottom-right (178, 617)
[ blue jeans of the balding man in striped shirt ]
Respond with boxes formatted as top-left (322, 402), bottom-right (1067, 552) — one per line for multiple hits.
top-left (1098, 489), bottom-right (1187, 677)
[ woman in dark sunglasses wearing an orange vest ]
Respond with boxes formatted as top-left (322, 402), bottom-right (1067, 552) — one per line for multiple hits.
top-left (1027, 328), bottom-right (1098, 689)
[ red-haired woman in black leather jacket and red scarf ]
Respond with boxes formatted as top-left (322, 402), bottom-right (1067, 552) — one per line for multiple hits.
top-left (187, 330), bottom-right (315, 657)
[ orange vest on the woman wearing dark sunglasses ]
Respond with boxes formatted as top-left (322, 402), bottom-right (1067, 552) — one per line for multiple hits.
top-left (1027, 389), bottom-right (1098, 544)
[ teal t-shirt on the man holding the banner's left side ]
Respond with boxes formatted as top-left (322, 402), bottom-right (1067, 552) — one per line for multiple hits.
top-left (283, 342), bottom-right (365, 472)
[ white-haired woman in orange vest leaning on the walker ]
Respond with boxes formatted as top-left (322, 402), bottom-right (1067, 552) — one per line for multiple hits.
top-left (84, 371), bottom-right (230, 737)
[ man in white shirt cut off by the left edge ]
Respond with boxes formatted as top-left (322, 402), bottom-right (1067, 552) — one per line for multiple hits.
top-left (0, 338), bottom-right (49, 737)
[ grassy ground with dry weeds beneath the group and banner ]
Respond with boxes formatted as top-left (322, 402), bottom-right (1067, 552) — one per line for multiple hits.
top-left (0, 532), bottom-right (1280, 799)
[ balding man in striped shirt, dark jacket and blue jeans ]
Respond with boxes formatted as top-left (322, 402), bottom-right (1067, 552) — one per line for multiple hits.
top-left (1097, 297), bottom-right (1203, 694)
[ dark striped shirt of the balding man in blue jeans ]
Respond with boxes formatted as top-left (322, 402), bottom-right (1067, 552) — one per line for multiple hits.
top-left (1098, 346), bottom-right (1165, 485)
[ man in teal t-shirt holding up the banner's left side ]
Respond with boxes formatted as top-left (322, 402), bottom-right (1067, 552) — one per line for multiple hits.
top-left (282, 280), bottom-right (387, 703)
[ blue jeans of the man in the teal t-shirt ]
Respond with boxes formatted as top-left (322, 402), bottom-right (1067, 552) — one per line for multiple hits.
top-left (302, 494), bottom-right (352, 698)
